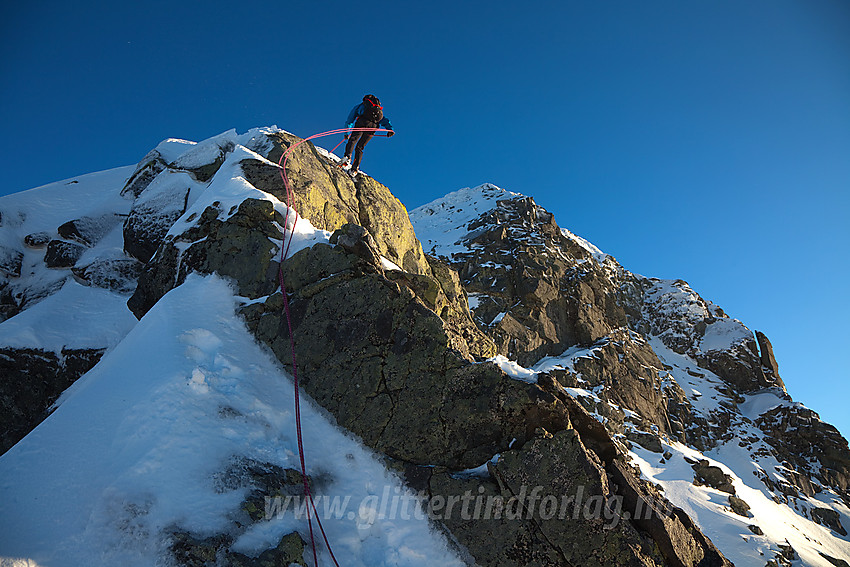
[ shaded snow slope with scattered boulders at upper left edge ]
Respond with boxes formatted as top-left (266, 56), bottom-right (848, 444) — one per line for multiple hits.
top-left (0, 166), bottom-right (136, 353)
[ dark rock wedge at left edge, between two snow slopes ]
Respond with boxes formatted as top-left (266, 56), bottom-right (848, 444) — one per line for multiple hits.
top-left (0, 348), bottom-right (104, 453)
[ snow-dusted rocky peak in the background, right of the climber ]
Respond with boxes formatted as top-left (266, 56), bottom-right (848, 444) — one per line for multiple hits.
top-left (411, 186), bottom-right (848, 557)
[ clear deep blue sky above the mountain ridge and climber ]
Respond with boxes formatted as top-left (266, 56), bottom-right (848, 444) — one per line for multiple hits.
top-left (0, 0), bottom-right (850, 435)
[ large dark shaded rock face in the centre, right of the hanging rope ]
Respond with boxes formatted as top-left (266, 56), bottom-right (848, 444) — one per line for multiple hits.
top-left (243, 244), bottom-right (565, 469)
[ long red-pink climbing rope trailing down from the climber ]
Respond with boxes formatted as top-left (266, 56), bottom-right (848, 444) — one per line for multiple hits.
top-left (277, 128), bottom-right (389, 567)
